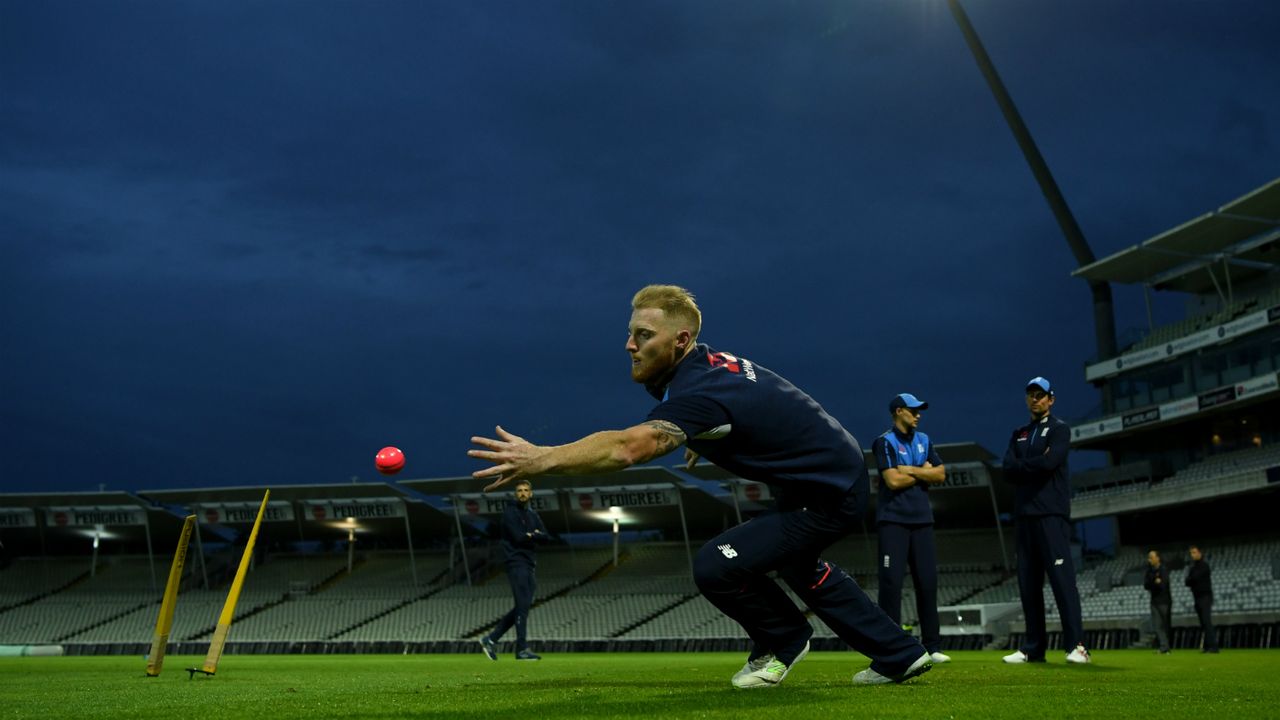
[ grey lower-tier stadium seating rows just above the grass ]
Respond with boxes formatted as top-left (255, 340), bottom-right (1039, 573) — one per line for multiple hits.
top-left (0, 532), bottom-right (1280, 644)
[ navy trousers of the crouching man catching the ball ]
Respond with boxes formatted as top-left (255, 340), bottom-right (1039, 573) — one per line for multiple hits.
top-left (694, 480), bottom-right (924, 675)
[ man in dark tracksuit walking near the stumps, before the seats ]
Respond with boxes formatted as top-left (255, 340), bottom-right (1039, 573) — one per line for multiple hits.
top-left (480, 480), bottom-right (549, 660)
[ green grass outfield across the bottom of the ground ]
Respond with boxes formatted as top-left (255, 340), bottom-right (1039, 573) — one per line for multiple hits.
top-left (0, 650), bottom-right (1280, 720)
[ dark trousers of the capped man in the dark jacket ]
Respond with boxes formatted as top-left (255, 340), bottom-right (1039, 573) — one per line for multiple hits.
top-left (1014, 515), bottom-right (1084, 660)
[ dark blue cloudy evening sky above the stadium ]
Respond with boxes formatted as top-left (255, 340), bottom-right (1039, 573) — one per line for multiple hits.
top-left (0, 0), bottom-right (1280, 492)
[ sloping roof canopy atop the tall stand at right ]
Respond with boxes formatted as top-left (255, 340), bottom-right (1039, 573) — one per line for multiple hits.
top-left (1071, 178), bottom-right (1280, 295)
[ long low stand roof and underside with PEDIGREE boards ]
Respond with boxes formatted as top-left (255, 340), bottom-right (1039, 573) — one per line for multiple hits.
top-left (0, 443), bottom-right (1010, 556)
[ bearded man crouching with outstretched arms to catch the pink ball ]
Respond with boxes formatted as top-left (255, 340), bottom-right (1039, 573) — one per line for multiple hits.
top-left (468, 286), bottom-right (931, 689)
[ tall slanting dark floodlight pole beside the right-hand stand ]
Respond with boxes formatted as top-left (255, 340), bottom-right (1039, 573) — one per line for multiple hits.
top-left (947, 0), bottom-right (1116, 376)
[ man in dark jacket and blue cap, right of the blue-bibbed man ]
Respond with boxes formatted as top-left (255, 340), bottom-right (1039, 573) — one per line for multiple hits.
top-left (1004, 377), bottom-right (1091, 665)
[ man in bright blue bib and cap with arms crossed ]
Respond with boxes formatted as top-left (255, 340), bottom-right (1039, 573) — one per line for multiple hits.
top-left (872, 392), bottom-right (951, 662)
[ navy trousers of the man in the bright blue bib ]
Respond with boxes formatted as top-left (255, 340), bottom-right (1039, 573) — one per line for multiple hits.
top-left (876, 523), bottom-right (942, 652)
